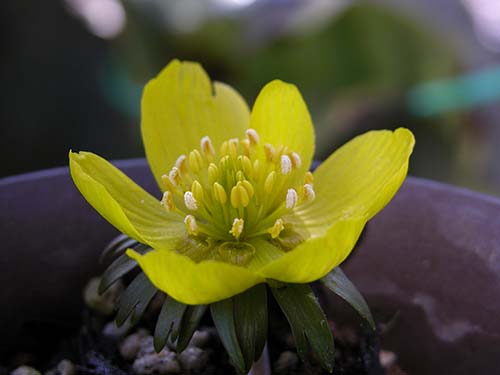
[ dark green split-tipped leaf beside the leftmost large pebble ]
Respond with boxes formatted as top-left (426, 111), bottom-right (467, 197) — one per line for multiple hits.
top-left (116, 272), bottom-right (157, 327)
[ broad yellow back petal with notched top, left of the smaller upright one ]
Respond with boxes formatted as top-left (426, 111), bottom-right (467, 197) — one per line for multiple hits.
top-left (141, 60), bottom-right (250, 186)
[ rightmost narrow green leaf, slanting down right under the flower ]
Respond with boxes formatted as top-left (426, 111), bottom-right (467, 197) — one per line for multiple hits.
top-left (321, 267), bottom-right (375, 330)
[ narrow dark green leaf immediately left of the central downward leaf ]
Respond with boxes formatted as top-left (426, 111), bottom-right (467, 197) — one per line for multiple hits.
top-left (210, 298), bottom-right (246, 372)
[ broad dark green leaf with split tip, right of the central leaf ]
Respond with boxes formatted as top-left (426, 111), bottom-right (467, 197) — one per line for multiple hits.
top-left (271, 284), bottom-right (335, 372)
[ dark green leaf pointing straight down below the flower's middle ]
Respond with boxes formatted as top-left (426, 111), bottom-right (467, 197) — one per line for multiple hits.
top-left (233, 284), bottom-right (267, 368)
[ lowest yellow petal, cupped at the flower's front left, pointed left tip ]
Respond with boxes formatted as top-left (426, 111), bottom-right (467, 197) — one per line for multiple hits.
top-left (127, 249), bottom-right (264, 305)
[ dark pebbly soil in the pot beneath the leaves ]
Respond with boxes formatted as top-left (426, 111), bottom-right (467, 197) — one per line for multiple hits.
top-left (0, 280), bottom-right (406, 375)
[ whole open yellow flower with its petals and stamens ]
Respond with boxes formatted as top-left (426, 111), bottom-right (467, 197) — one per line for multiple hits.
top-left (70, 61), bottom-right (414, 304)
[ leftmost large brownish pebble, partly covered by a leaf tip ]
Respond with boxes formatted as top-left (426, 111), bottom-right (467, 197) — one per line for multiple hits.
top-left (83, 277), bottom-right (123, 315)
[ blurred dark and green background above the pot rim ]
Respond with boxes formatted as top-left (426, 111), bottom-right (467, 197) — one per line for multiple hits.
top-left (0, 0), bottom-right (500, 195)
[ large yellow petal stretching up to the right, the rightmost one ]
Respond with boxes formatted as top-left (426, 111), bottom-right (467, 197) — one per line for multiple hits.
top-left (295, 128), bottom-right (415, 237)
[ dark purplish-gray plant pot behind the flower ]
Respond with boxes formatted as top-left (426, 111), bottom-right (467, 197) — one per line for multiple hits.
top-left (0, 159), bottom-right (500, 374)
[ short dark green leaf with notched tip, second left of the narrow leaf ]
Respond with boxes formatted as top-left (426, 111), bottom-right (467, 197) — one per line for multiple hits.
top-left (153, 296), bottom-right (187, 353)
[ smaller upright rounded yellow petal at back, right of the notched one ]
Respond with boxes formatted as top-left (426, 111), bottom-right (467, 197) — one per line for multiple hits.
top-left (250, 80), bottom-right (314, 170)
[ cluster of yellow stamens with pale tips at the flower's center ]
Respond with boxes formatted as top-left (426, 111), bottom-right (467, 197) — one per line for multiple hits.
top-left (161, 129), bottom-right (315, 258)
